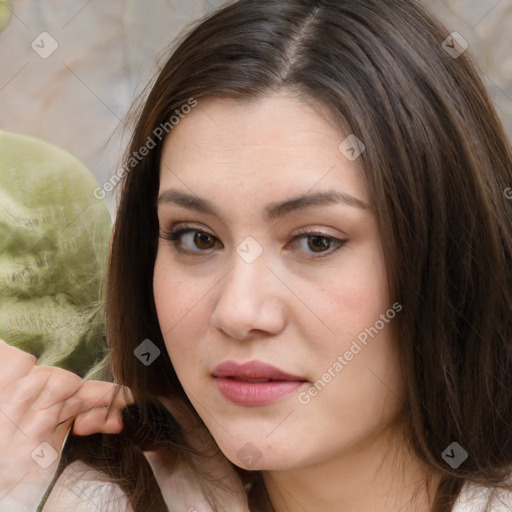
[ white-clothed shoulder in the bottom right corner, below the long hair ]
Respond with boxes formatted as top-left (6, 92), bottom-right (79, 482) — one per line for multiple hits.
top-left (452, 472), bottom-right (512, 512)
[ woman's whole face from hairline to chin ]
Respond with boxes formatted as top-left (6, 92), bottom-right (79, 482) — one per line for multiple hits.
top-left (154, 92), bottom-right (403, 470)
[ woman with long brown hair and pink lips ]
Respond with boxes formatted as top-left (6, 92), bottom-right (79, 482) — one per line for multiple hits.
top-left (1, 0), bottom-right (512, 512)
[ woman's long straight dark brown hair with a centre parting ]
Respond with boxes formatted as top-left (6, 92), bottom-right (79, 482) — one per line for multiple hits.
top-left (57, 0), bottom-right (512, 512)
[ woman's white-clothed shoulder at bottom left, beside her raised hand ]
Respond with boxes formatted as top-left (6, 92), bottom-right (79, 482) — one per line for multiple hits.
top-left (43, 461), bottom-right (133, 512)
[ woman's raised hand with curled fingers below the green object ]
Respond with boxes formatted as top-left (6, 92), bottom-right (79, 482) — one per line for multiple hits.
top-left (0, 340), bottom-right (129, 512)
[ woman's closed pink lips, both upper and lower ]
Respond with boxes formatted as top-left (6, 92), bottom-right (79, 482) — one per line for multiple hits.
top-left (212, 361), bottom-right (306, 407)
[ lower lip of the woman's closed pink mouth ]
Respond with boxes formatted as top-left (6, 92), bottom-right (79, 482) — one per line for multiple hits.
top-left (215, 377), bottom-right (304, 407)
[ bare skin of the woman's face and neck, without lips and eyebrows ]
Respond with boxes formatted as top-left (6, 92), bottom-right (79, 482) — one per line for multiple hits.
top-left (154, 90), bottom-right (438, 512)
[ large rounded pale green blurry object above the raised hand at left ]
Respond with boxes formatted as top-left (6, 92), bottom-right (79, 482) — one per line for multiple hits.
top-left (0, 131), bottom-right (112, 378)
